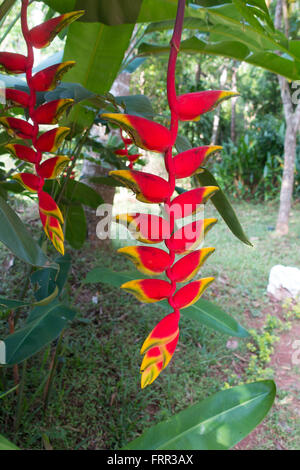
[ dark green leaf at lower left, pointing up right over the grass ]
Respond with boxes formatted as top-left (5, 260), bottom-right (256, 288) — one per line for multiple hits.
top-left (4, 302), bottom-right (76, 365)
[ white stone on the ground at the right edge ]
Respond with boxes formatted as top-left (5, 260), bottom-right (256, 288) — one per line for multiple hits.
top-left (267, 264), bottom-right (300, 299)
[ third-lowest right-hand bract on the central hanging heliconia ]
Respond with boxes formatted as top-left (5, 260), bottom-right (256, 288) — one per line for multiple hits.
top-left (165, 218), bottom-right (217, 254)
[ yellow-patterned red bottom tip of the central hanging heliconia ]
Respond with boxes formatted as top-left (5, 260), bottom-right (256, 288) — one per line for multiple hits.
top-left (141, 313), bottom-right (179, 388)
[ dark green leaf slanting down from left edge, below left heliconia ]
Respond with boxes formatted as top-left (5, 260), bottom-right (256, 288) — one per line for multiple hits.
top-left (0, 197), bottom-right (49, 266)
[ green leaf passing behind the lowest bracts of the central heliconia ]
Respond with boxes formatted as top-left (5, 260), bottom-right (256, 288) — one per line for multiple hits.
top-left (83, 268), bottom-right (249, 338)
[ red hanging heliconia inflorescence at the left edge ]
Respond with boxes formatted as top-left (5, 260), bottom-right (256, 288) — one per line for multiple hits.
top-left (0, 0), bottom-right (84, 254)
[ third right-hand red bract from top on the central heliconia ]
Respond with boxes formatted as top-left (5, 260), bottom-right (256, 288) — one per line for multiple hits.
top-left (170, 186), bottom-right (219, 219)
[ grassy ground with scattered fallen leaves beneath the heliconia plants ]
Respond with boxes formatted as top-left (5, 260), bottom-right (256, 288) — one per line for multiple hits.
top-left (0, 196), bottom-right (300, 449)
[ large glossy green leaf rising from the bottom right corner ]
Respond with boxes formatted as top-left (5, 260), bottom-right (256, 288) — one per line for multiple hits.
top-left (125, 380), bottom-right (276, 450)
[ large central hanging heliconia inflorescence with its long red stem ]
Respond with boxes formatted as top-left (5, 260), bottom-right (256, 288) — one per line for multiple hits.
top-left (102, 0), bottom-right (237, 388)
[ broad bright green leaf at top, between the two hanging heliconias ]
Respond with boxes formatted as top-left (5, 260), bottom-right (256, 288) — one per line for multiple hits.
top-left (64, 22), bottom-right (133, 94)
